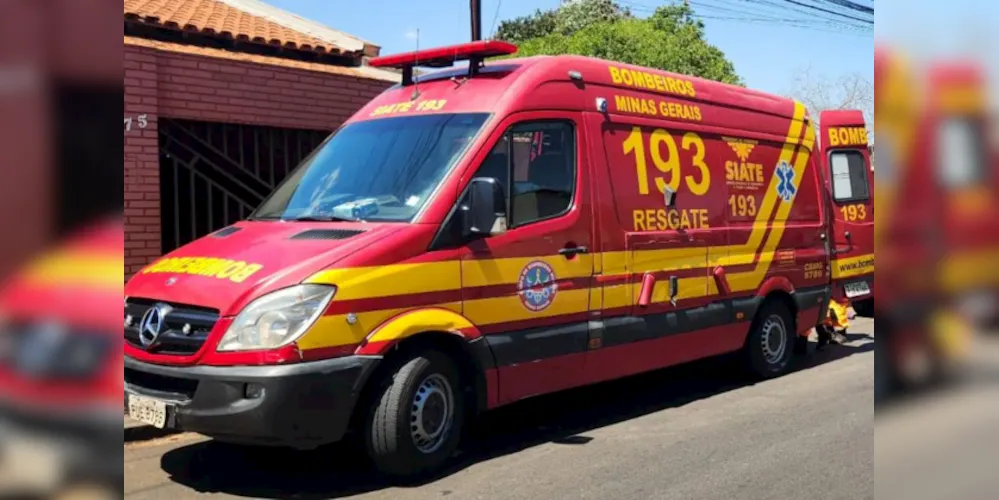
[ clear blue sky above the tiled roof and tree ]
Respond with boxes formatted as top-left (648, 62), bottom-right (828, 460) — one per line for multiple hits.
top-left (266, 0), bottom-right (876, 94)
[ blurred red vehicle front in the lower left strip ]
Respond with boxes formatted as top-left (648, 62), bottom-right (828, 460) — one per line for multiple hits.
top-left (0, 220), bottom-right (124, 494)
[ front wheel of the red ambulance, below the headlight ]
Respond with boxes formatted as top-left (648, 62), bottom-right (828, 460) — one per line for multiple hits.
top-left (364, 350), bottom-right (465, 479)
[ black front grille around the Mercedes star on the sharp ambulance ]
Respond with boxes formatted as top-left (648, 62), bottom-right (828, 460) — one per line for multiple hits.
top-left (125, 298), bottom-right (219, 356)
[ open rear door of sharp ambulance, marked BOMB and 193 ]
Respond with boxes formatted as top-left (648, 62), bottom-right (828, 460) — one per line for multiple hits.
top-left (820, 110), bottom-right (874, 302)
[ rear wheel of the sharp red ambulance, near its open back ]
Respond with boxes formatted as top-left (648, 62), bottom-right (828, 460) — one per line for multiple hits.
top-left (744, 300), bottom-right (797, 379)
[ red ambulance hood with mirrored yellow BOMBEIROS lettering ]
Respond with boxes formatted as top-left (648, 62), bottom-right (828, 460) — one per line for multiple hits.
top-left (125, 221), bottom-right (407, 316)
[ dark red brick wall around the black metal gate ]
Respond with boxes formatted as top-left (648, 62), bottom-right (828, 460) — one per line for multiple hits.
top-left (124, 45), bottom-right (391, 280)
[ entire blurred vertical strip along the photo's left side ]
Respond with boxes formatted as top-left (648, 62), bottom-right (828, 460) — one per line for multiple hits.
top-left (0, 0), bottom-right (124, 498)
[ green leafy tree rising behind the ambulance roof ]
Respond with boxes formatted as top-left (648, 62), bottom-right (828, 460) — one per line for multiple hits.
top-left (494, 5), bottom-right (743, 85)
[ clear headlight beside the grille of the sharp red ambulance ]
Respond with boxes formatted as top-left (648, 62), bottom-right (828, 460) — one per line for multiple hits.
top-left (218, 285), bottom-right (336, 351)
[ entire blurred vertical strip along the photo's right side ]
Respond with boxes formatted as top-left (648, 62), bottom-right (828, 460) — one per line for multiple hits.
top-left (875, 0), bottom-right (999, 500)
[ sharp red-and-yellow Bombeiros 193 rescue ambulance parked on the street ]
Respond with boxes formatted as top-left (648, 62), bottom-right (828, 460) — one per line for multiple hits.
top-left (124, 42), bottom-right (873, 476)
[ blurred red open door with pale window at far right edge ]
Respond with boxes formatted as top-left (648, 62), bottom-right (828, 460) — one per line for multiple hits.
top-left (924, 61), bottom-right (999, 326)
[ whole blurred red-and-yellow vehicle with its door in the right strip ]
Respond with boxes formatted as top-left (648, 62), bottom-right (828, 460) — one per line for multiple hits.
top-left (875, 49), bottom-right (980, 395)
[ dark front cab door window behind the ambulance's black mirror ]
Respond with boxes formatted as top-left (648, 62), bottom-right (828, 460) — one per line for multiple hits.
top-left (476, 121), bottom-right (576, 228)
